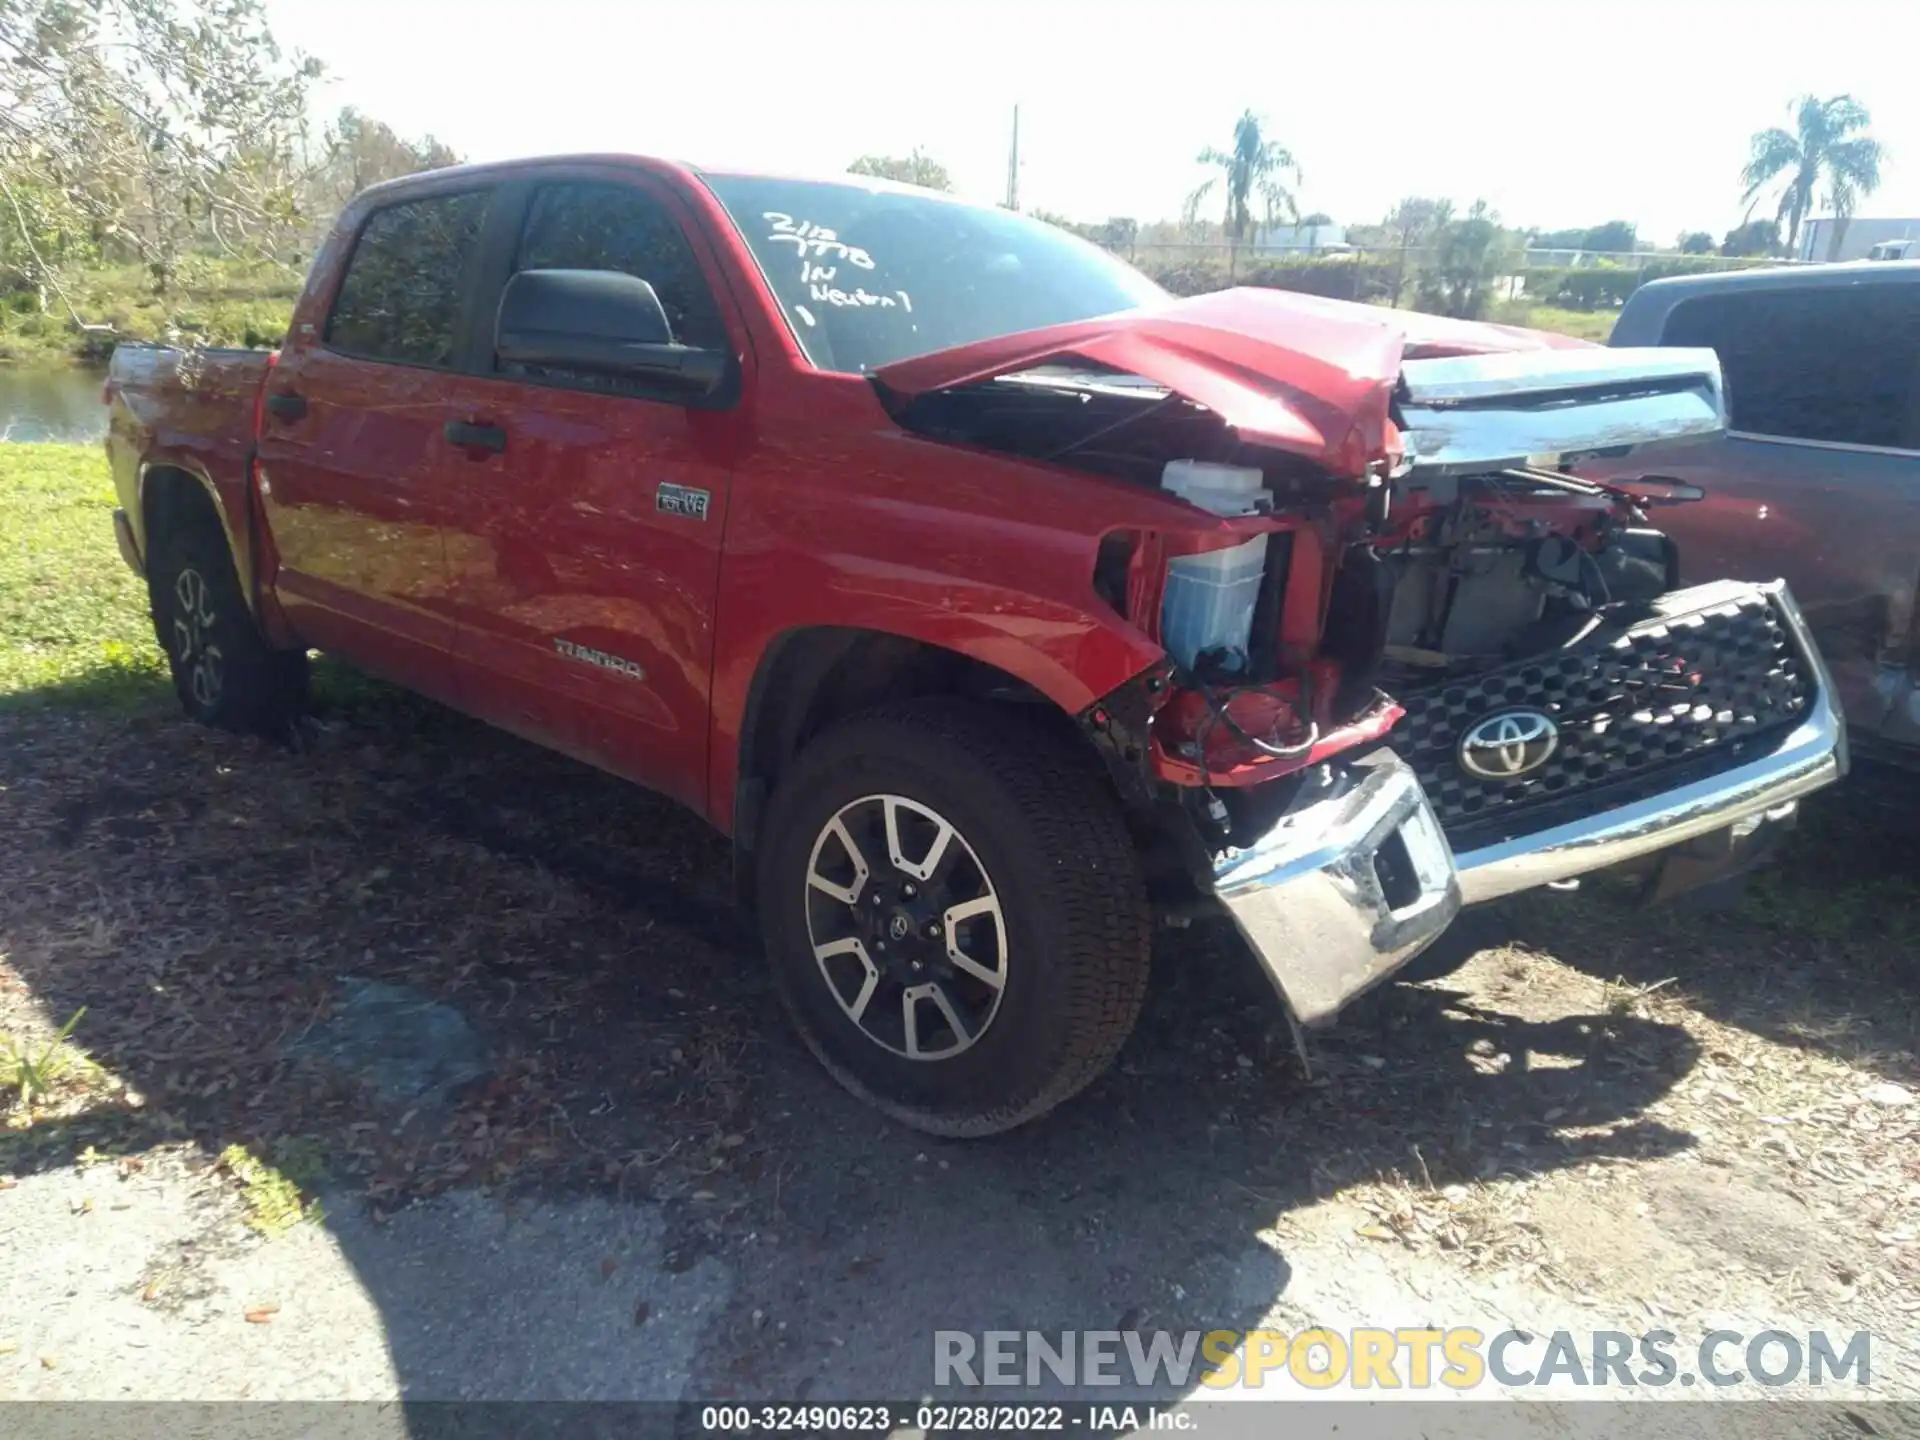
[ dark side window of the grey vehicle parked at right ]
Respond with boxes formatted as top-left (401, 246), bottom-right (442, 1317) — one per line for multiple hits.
top-left (1661, 284), bottom-right (1920, 449)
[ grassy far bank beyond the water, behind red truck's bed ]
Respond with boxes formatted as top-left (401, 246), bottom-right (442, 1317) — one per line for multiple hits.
top-left (0, 255), bottom-right (301, 365)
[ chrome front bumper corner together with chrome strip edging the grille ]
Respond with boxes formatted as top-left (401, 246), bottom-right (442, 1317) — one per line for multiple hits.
top-left (1213, 582), bottom-right (1847, 1025)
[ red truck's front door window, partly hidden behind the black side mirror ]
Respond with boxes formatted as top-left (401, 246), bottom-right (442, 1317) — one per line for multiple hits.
top-left (513, 180), bottom-right (730, 349)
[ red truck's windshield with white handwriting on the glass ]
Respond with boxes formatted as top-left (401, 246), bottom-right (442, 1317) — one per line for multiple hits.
top-left (703, 175), bottom-right (1167, 374)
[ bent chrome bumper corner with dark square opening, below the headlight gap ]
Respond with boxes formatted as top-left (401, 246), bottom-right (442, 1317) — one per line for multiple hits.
top-left (1213, 755), bottom-right (1461, 1025)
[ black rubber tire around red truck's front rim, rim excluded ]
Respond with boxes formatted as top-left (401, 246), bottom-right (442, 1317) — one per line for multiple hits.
top-left (758, 699), bottom-right (1152, 1137)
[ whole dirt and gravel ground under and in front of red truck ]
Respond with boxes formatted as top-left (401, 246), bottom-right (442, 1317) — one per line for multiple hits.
top-left (0, 689), bottom-right (1920, 1434)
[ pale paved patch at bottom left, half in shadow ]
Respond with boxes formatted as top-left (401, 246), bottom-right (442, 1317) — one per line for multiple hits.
top-left (0, 1152), bottom-right (732, 1400)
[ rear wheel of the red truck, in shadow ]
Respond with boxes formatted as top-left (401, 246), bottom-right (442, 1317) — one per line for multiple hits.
top-left (146, 495), bottom-right (307, 739)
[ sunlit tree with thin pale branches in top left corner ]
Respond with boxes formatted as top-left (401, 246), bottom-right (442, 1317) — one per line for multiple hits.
top-left (0, 0), bottom-right (453, 328)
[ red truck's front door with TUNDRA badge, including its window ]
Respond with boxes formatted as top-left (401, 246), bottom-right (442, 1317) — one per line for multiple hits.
top-left (445, 167), bottom-right (751, 806)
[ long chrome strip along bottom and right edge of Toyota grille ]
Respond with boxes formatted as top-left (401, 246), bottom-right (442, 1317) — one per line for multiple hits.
top-left (1457, 580), bottom-right (1847, 904)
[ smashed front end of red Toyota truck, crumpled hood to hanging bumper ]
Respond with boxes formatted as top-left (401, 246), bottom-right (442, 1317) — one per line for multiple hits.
top-left (881, 300), bottom-right (1845, 1025)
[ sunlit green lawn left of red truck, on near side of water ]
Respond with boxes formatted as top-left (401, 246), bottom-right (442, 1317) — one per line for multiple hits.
top-left (0, 445), bottom-right (165, 708)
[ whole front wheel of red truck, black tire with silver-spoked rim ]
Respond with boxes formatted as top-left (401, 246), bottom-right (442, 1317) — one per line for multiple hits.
top-left (758, 701), bottom-right (1152, 1137)
